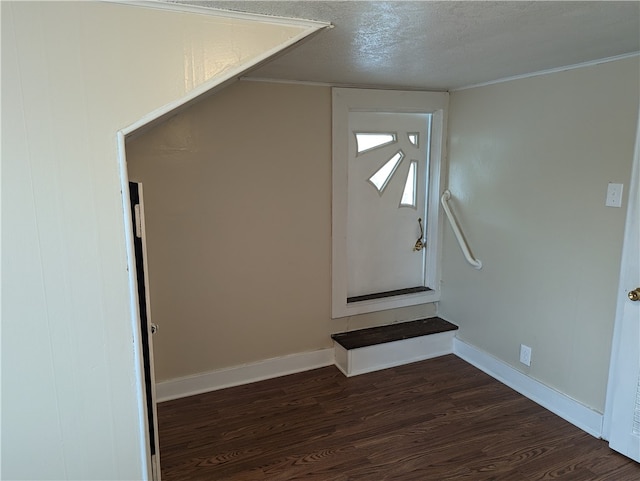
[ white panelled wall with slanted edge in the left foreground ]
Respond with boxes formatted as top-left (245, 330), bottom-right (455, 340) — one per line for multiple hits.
top-left (1, 2), bottom-right (320, 480)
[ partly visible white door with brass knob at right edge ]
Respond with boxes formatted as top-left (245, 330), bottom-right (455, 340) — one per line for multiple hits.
top-left (605, 112), bottom-right (640, 462)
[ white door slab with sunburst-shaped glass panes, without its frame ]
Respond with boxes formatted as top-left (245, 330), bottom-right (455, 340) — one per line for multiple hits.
top-left (347, 112), bottom-right (431, 302)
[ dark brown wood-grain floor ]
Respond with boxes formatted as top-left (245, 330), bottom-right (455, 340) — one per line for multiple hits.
top-left (158, 355), bottom-right (640, 481)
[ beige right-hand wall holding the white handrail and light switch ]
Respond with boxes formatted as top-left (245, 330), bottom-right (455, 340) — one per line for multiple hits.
top-left (439, 57), bottom-right (640, 412)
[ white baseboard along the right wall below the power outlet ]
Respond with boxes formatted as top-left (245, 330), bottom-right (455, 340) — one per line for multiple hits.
top-left (453, 338), bottom-right (604, 438)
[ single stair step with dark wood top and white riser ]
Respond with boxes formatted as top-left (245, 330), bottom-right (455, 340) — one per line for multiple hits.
top-left (331, 317), bottom-right (458, 376)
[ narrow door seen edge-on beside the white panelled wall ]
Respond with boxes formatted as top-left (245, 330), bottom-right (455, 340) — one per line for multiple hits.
top-left (129, 182), bottom-right (160, 481)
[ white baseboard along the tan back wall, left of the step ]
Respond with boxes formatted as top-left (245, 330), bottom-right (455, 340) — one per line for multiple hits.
top-left (156, 348), bottom-right (334, 402)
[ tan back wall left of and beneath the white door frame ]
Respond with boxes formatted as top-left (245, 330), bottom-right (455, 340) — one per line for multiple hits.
top-left (127, 82), bottom-right (435, 381)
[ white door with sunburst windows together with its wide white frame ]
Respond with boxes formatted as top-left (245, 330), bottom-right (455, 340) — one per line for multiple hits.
top-left (332, 88), bottom-right (448, 318)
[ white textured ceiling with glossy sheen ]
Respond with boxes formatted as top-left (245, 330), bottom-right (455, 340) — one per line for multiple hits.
top-left (169, 0), bottom-right (640, 90)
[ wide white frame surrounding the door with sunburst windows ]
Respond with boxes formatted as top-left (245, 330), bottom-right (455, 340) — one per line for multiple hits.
top-left (331, 88), bottom-right (449, 319)
